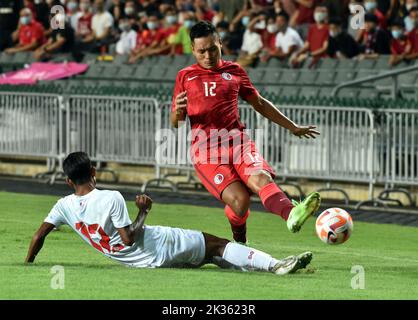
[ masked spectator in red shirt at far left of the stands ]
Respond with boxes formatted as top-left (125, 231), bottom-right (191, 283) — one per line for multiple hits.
top-left (5, 8), bottom-right (45, 54)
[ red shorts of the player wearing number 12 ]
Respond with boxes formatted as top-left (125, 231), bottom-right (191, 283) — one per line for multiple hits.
top-left (192, 139), bottom-right (276, 201)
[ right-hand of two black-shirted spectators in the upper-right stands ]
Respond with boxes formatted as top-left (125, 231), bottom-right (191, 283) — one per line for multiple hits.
top-left (359, 13), bottom-right (390, 60)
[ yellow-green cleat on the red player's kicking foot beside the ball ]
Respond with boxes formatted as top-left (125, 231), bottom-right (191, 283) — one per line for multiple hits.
top-left (287, 192), bottom-right (321, 232)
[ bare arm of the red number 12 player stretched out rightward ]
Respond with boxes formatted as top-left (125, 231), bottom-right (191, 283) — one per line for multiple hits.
top-left (247, 95), bottom-right (320, 139)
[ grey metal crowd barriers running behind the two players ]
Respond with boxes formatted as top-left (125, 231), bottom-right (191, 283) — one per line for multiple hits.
top-left (0, 93), bottom-right (418, 208)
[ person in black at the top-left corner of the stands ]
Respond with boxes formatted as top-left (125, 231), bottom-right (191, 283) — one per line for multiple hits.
top-left (0, 0), bottom-right (23, 52)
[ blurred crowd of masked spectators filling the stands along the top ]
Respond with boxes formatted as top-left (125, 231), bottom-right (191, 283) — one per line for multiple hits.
top-left (0, 0), bottom-right (418, 67)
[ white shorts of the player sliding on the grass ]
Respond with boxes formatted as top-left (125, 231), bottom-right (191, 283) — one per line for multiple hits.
top-left (136, 226), bottom-right (206, 268)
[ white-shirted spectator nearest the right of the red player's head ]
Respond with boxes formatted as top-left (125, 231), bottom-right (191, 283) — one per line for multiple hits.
top-left (237, 15), bottom-right (267, 68)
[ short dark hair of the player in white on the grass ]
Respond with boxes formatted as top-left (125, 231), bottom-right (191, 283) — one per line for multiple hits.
top-left (62, 151), bottom-right (92, 185)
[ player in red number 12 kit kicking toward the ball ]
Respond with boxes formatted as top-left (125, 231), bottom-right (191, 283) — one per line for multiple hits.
top-left (171, 21), bottom-right (320, 243)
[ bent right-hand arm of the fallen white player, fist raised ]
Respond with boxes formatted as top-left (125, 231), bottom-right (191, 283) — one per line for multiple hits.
top-left (117, 194), bottom-right (152, 246)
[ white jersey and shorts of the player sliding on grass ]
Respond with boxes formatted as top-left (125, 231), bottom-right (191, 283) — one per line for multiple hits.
top-left (44, 189), bottom-right (205, 267)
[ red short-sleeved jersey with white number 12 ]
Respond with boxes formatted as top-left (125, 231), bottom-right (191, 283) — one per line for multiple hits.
top-left (172, 60), bottom-right (258, 143)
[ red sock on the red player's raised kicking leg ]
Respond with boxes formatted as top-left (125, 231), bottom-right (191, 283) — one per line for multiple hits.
top-left (258, 182), bottom-right (293, 221)
